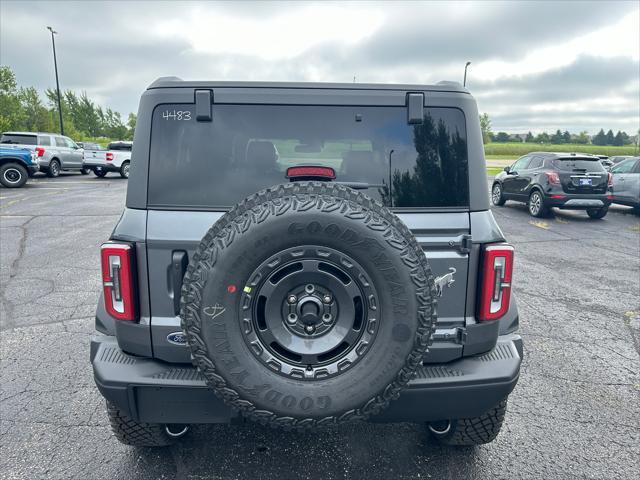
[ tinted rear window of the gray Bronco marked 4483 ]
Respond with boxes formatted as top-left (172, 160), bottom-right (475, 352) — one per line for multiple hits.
top-left (148, 104), bottom-right (469, 209)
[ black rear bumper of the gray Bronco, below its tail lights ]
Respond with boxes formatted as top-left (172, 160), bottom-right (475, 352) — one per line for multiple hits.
top-left (91, 334), bottom-right (522, 423)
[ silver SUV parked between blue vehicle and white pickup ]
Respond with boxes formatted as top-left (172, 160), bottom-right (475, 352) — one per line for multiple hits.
top-left (0, 132), bottom-right (88, 177)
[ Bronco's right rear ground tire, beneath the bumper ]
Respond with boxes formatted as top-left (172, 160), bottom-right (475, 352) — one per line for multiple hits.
top-left (429, 397), bottom-right (507, 446)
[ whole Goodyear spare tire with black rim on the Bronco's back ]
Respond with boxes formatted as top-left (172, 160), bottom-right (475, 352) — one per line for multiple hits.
top-left (181, 182), bottom-right (436, 429)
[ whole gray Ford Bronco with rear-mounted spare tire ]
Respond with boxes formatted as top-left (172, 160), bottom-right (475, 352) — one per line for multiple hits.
top-left (91, 77), bottom-right (522, 446)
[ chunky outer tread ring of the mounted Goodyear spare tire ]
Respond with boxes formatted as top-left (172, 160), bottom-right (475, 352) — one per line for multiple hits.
top-left (180, 182), bottom-right (436, 430)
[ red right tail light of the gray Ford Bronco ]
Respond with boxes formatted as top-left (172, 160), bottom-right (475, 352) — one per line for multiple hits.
top-left (478, 243), bottom-right (514, 322)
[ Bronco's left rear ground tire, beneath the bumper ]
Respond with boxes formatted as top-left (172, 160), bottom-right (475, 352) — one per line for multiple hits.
top-left (106, 401), bottom-right (188, 447)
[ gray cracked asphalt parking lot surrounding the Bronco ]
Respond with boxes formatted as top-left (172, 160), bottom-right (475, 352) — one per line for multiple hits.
top-left (0, 174), bottom-right (640, 479)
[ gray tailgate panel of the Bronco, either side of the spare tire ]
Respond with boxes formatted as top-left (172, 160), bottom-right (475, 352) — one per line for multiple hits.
top-left (146, 210), bottom-right (470, 363)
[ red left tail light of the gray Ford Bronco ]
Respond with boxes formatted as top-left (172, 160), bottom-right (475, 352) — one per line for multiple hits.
top-left (100, 243), bottom-right (137, 320)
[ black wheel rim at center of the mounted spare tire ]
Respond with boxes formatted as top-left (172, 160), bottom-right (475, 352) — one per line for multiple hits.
top-left (240, 246), bottom-right (379, 380)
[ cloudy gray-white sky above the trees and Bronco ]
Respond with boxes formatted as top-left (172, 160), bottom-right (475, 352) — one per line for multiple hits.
top-left (0, 0), bottom-right (640, 133)
